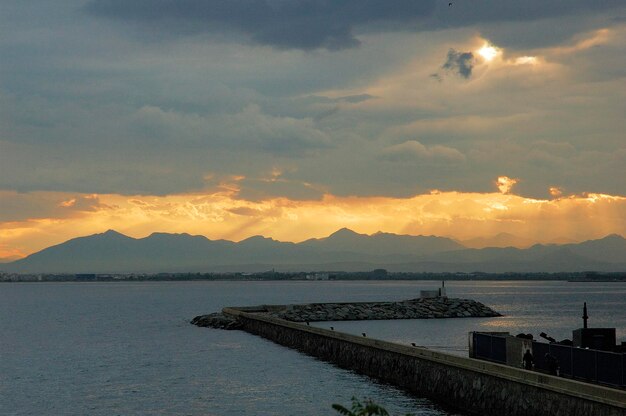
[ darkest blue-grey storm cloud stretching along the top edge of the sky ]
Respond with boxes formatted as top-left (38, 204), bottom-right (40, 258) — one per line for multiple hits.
top-left (87, 0), bottom-right (624, 50)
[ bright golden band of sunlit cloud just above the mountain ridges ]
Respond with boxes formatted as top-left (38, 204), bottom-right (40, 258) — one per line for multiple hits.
top-left (0, 180), bottom-right (626, 258)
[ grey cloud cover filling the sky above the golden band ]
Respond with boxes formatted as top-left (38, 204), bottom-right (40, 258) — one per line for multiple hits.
top-left (0, 0), bottom-right (626, 201)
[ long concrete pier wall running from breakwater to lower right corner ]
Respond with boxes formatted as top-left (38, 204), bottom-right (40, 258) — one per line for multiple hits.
top-left (223, 308), bottom-right (626, 416)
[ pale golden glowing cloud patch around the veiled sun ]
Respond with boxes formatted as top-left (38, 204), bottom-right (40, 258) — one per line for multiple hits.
top-left (320, 36), bottom-right (552, 113)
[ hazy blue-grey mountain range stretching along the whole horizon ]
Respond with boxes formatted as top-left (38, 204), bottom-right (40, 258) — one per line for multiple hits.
top-left (0, 228), bottom-right (626, 273)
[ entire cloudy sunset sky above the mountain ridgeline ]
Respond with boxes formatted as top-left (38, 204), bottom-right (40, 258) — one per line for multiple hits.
top-left (0, 0), bottom-right (626, 259)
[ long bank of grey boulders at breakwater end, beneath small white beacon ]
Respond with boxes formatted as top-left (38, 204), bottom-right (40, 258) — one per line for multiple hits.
top-left (266, 297), bottom-right (502, 322)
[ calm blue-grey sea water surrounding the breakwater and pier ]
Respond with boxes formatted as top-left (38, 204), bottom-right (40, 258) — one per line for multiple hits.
top-left (0, 281), bottom-right (626, 416)
